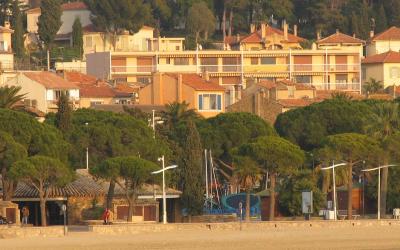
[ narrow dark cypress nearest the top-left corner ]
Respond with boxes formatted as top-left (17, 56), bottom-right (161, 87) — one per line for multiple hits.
top-left (11, 0), bottom-right (24, 58)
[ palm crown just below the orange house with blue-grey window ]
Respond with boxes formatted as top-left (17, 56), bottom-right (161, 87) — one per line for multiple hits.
top-left (161, 101), bottom-right (199, 129)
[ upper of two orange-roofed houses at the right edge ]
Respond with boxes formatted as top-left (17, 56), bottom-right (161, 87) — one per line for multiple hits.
top-left (366, 26), bottom-right (400, 56)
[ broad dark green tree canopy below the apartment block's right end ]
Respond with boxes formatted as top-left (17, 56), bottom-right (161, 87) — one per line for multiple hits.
top-left (275, 98), bottom-right (372, 150)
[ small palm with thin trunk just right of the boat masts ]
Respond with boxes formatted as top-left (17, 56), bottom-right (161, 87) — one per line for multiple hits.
top-left (234, 157), bottom-right (262, 221)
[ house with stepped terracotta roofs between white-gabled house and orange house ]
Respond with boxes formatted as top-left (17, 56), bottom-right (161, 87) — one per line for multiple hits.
top-left (63, 71), bottom-right (132, 108)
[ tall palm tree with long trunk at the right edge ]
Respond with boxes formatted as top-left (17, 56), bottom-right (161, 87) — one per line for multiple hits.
top-left (367, 102), bottom-right (400, 216)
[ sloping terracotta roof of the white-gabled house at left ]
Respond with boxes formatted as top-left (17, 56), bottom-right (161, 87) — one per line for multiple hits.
top-left (22, 71), bottom-right (78, 89)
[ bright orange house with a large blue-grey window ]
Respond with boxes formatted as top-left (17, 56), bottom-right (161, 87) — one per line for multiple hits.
top-left (139, 73), bottom-right (226, 117)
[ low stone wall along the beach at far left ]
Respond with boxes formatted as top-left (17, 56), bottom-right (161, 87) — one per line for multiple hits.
top-left (0, 225), bottom-right (64, 239)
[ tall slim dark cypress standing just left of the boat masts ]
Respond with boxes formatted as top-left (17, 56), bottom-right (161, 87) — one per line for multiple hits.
top-left (181, 120), bottom-right (204, 215)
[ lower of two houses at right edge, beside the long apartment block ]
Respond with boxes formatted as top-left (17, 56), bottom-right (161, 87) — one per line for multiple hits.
top-left (362, 50), bottom-right (400, 88)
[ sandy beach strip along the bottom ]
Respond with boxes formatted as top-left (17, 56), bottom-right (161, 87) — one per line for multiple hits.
top-left (0, 226), bottom-right (400, 250)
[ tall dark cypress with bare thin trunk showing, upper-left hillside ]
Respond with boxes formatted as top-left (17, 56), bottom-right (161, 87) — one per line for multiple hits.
top-left (38, 0), bottom-right (62, 70)
